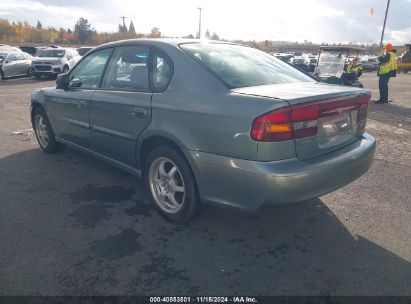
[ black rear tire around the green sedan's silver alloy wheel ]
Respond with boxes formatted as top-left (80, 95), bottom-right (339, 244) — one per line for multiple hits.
top-left (144, 146), bottom-right (204, 225)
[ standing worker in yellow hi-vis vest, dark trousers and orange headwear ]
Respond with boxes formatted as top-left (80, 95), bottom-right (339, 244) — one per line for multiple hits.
top-left (375, 43), bottom-right (397, 103)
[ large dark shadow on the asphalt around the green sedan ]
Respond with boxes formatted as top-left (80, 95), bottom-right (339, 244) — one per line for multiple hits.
top-left (0, 149), bottom-right (411, 295)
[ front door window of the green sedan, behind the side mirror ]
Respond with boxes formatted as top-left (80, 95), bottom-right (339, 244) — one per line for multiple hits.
top-left (69, 49), bottom-right (113, 89)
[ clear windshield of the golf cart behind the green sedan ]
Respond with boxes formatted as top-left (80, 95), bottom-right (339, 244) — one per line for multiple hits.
top-left (315, 51), bottom-right (347, 77)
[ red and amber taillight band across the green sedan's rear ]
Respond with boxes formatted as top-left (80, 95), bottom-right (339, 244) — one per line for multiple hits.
top-left (250, 94), bottom-right (370, 142)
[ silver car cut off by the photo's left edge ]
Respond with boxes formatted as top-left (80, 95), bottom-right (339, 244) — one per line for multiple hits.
top-left (0, 51), bottom-right (33, 79)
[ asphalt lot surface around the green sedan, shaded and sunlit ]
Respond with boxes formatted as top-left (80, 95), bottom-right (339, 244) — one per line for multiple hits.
top-left (0, 74), bottom-right (411, 295)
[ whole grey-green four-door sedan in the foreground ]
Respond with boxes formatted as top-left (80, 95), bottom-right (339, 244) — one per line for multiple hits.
top-left (31, 39), bottom-right (375, 223)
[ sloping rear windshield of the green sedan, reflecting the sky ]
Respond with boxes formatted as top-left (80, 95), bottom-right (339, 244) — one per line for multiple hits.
top-left (180, 43), bottom-right (314, 88)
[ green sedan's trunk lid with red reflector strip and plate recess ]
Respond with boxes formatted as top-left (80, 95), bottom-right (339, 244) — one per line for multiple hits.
top-left (234, 82), bottom-right (370, 159)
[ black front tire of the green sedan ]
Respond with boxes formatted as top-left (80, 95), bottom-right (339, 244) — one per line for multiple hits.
top-left (32, 107), bottom-right (64, 153)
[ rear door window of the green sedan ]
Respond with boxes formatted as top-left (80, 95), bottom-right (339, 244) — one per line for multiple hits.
top-left (101, 46), bottom-right (150, 91)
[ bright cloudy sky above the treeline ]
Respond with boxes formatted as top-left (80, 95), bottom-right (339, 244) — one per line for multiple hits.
top-left (0, 0), bottom-right (411, 44)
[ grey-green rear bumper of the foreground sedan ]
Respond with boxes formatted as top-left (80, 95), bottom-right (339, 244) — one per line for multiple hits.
top-left (188, 133), bottom-right (376, 210)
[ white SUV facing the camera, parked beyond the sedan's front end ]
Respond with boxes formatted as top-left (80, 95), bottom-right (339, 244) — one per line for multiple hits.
top-left (31, 47), bottom-right (81, 78)
